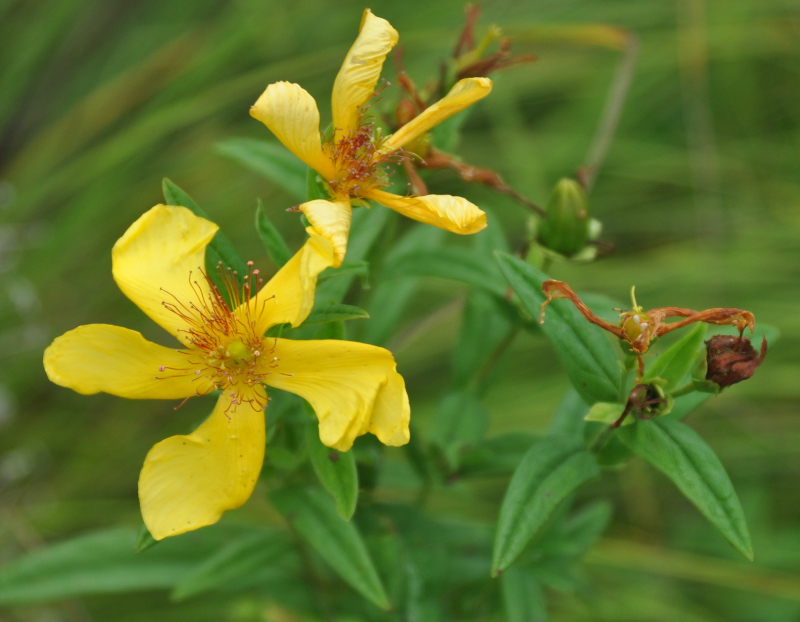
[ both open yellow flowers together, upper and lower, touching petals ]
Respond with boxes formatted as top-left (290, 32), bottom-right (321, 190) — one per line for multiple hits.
top-left (44, 10), bottom-right (491, 540)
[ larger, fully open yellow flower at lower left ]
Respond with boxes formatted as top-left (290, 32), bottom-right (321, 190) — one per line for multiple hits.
top-left (44, 205), bottom-right (409, 540)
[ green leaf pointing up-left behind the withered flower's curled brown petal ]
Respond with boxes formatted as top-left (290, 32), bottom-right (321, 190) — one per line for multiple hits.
top-left (495, 253), bottom-right (621, 404)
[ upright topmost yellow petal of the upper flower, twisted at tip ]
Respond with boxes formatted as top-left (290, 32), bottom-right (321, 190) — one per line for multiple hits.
top-left (332, 9), bottom-right (399, 137)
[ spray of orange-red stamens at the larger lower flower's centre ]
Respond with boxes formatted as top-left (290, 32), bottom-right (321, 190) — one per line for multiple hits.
top-left (159, 262), bottom-right (278, 410)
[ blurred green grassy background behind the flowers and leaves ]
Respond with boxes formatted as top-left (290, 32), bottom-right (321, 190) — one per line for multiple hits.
top-left (0, 0), bottom-right (800, 622)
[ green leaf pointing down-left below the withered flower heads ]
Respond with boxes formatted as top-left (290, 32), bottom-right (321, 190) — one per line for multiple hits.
top-left (492, 436), bottom-right (600, 575)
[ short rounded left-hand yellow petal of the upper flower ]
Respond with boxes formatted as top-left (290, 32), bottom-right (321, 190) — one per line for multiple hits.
top-left (250, 82), bottom-right (336, 179)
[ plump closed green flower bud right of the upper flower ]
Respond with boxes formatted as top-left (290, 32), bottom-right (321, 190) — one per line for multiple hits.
top-left (539, 177), bottom-right (589, 257)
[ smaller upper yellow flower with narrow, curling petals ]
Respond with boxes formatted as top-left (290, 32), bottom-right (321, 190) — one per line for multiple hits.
top-left (250, 9), bottom-right (492, 267)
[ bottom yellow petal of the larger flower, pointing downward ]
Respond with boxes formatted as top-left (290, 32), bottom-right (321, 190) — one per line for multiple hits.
top-left (139, 394), bottom-right (266, 540)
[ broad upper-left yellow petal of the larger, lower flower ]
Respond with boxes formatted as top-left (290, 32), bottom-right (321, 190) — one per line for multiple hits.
top-left (111, 205), bottom-right (219, 343)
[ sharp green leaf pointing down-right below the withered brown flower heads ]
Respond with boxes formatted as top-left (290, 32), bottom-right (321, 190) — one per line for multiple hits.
top-left (617, 418), bottom-right (753, 560)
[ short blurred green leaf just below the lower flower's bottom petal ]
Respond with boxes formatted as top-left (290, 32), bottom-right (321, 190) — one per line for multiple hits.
top-left (171, 530), bottom-right (290, 601)
